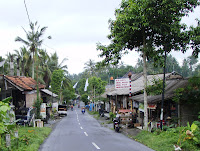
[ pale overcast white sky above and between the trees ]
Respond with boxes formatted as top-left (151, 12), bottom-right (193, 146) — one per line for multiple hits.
top-left (0, 0), bottom-right (200, 74)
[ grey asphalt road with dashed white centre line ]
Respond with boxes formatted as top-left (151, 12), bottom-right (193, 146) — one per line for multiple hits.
top-left (39, 104), bottom-right (152, 151)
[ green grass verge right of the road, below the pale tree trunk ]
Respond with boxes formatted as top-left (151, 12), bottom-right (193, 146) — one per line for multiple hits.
top-left (132, 127), bottom-right (200, 151)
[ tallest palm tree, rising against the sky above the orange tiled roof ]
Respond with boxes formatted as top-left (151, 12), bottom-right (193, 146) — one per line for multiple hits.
top-left (15, 22), bottom-right (48, 79)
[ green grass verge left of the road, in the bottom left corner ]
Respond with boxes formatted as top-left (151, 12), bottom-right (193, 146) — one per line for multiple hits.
top-left (0, 127), bottom-right (51, 151)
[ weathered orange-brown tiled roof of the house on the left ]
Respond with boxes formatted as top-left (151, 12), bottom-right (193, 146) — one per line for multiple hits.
top-left (4, 76), bottom-right (45, 91)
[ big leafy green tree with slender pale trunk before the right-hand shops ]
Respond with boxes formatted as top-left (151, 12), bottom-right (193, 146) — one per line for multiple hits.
top-left (97, 0), bottom-right (197, 129)
